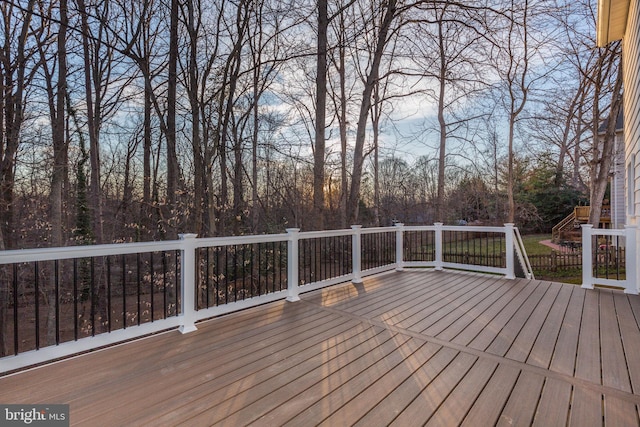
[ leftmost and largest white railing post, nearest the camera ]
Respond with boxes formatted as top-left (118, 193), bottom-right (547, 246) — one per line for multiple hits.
top-left (178, 233), bottom-right (198, 334)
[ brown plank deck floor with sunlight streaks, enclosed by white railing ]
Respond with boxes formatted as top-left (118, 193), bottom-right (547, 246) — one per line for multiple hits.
top-left (0, 271), bottom-right (640, 426)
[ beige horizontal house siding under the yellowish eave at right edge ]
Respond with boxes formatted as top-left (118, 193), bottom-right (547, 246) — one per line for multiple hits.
top-left (622, 0), bottom-right (640, 225)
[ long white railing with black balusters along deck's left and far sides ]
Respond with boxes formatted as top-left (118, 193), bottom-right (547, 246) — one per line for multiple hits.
top-left (0, 223), bottom-right (526, 372)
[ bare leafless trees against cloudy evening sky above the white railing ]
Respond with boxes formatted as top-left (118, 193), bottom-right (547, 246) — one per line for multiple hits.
top-left (0, 0), bottom-right (622, 249)
